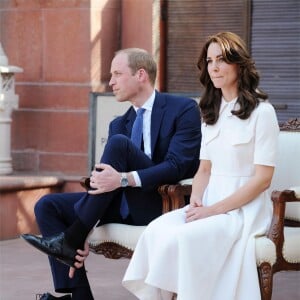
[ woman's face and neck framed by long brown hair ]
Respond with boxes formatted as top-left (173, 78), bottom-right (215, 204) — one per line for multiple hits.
top-left (206, 43), bottom-right (239, 101)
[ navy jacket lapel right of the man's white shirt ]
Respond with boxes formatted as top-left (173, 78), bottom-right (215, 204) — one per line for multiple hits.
top-left (151, 92), bottom-right (166, 155)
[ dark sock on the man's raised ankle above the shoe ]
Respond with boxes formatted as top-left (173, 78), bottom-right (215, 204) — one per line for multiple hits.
top-left (65, 218), bottom-right (89, 249)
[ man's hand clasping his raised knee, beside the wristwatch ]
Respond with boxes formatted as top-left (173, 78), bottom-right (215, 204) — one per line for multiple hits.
top-left (88, 164), bottom-right (121, 195)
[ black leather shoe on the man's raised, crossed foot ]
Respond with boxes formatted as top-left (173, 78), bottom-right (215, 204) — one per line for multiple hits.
top-left (21, 232), bottom-right (77, 267)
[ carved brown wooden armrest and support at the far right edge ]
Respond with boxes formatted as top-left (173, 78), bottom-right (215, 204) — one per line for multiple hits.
top-left (267, 190), bottom-right (300, 260)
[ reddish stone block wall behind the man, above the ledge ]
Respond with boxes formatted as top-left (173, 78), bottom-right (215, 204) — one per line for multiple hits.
top-left (0, 0), bottom-right (152, 176)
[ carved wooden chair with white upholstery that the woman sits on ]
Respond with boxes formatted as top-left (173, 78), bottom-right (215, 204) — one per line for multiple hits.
top-left (150, 119), bottom-right (300, 300)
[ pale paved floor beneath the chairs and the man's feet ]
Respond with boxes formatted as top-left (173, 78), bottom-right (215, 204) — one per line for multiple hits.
top-left (0, 239), bottom-right (300, 300)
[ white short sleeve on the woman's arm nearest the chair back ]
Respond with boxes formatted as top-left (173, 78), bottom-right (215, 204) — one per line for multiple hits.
top-left (254, 102), bottom-right (279, 166)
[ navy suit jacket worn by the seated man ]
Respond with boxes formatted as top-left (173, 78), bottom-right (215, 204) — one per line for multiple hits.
top-left (108, 92), bottom-right (201, 225)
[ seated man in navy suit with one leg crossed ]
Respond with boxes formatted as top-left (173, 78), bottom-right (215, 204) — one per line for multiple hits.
top-left (22, 48), bottom-right (201, 300)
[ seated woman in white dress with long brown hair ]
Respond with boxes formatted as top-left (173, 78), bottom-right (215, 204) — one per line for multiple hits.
top-left (123, 32), bottom-right (279, 300)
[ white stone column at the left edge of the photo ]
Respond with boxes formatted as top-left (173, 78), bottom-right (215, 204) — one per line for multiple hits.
top-left (0, 43), bottom-right (23, 175)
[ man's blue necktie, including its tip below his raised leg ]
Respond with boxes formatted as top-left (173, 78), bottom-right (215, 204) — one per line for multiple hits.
top-left (120, 108), bottom-right (145, 219)
